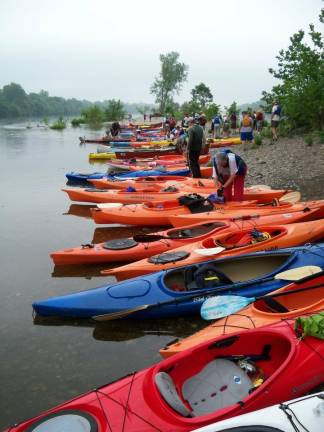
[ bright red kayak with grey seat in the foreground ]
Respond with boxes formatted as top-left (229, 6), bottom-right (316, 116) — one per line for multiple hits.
top-left (10, 321), bottom-right (324, 432)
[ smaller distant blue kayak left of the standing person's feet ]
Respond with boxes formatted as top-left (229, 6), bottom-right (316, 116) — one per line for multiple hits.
top-left (65, 168), bottom-right (190, 182)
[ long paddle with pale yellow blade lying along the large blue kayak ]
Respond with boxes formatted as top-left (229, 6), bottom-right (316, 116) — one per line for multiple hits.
top-left (92, 266), bottom-right (322, 321)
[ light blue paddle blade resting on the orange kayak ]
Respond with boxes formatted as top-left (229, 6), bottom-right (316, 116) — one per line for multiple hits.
top-left (200, 295), bottom-right (255, 321)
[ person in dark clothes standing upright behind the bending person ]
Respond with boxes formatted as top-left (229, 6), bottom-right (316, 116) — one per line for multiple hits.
top-left (187, 117), bottom-right (204, 178)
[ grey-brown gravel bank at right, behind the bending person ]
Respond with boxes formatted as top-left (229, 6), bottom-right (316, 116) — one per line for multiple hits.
top-left (213, 137), bottom-right (324, 199)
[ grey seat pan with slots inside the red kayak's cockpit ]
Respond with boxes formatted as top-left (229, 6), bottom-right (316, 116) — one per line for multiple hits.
top-left (182, 359), bottom-right (253, 416)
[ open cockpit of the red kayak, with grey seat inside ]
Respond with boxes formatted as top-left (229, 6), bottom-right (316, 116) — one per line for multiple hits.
top-left (154, 331), bottom-right (292, 418)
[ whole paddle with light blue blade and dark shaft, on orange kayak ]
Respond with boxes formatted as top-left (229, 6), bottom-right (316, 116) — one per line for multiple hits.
top-left (200, 269), bottom-right (324, 321)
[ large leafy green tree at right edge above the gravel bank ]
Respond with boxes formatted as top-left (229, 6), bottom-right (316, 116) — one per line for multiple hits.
top-left (262, 10), bottom-right (324, 129)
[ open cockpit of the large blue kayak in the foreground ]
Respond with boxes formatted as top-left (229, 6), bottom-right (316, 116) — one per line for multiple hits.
top-left (164, 254), bottom-right (291, 291)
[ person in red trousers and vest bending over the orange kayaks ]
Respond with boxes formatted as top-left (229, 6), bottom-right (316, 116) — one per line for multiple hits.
top-left (213, 150), bottom-right (247, 201)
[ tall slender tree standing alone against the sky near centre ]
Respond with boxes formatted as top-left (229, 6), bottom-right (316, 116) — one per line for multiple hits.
top-left (151, 51), bottom-right (188, 114)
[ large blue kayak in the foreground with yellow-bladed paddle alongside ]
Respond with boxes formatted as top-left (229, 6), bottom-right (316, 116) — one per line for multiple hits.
top-left (33, 243), bottom-right (324, 319)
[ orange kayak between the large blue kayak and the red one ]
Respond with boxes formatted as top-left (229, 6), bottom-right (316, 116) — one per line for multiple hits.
top-left (160, 273), bottom-right (324, 357)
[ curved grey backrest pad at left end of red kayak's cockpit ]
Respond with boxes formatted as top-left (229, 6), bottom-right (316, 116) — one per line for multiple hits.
top-left (154, 372), bottom-right (192, 417)
